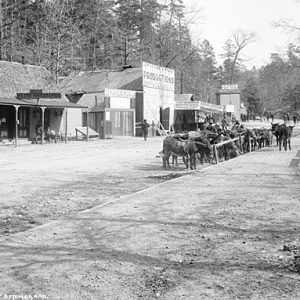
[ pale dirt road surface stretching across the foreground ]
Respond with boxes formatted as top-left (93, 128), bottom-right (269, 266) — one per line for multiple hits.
top-left (0, 120), bottom-right (300, 300)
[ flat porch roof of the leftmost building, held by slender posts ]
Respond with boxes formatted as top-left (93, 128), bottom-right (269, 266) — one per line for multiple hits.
top-left (0, 97), bottom-right (87, 108)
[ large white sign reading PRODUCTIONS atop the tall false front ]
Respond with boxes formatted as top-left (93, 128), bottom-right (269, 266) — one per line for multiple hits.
top-left (143, 62), bottom-right (175, 91)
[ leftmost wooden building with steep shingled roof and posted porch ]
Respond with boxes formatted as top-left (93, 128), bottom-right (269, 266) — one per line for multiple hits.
top-left (0, 61), bottom-right (84, 146)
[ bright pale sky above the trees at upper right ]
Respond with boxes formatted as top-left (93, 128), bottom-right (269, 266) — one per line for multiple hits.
top-left (183, 0), bottom-right (300, 69)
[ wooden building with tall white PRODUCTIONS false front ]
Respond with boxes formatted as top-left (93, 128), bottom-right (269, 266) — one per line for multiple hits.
top-left (62, 63), bottom-right (175, 138)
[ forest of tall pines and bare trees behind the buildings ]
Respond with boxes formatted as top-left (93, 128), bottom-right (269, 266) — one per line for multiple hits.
top-left (0, 0), bottom-right (300, 115)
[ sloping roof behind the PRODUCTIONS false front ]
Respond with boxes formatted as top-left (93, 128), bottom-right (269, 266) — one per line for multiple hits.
top-left (62, 68), bottom-right (143, 94)
